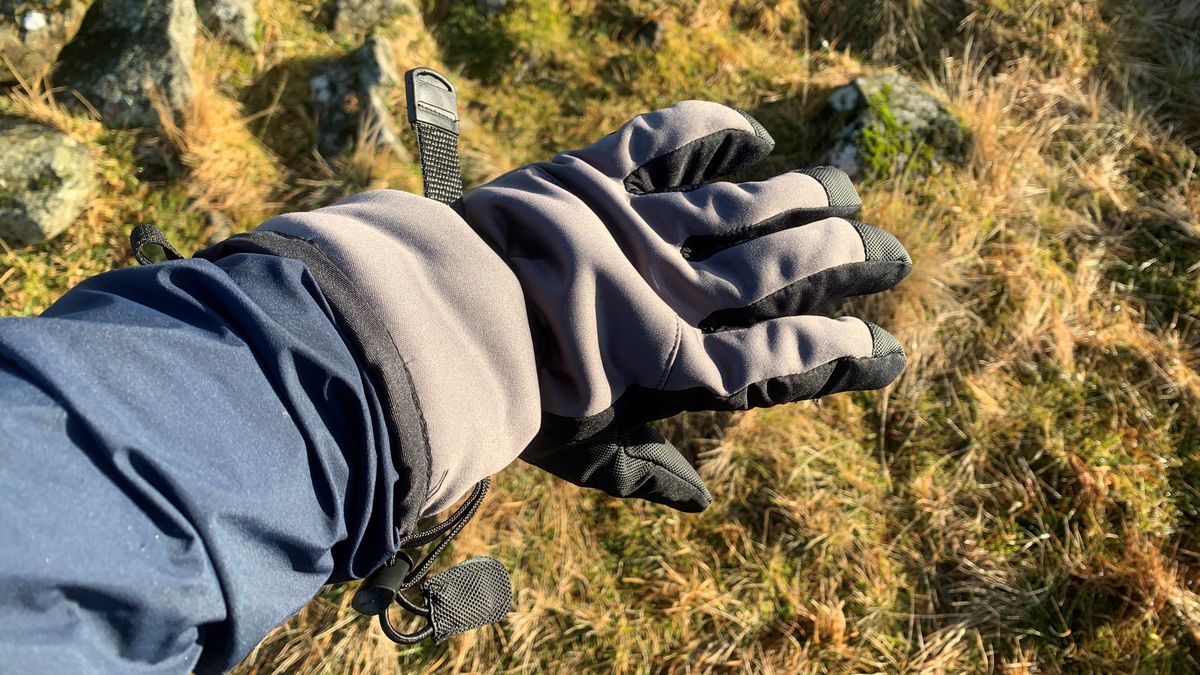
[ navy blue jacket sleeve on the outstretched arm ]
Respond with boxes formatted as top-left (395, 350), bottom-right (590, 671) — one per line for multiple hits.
top-left (0, 253), bottom-right (397, 673)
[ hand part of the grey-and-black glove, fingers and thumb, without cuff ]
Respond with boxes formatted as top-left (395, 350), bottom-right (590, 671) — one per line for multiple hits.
top-left (462, 101), bottom-right (912, 510)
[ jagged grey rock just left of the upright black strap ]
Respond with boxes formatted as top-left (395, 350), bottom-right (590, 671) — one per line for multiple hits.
top-left (308, 37), bottom-right (404, 157)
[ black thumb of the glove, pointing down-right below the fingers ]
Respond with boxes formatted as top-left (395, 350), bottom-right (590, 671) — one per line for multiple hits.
top-left (521, 425), bottom-right (713, 513)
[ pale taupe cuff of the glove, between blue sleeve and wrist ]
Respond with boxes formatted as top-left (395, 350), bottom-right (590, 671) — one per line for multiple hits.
top-left (210, 190), bottom-right (541, 515)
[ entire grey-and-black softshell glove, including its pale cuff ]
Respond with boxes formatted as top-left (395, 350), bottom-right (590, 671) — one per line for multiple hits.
top-left (257, 101), bottom-right (911, 514)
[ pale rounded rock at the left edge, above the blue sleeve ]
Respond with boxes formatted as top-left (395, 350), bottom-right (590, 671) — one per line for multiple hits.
top-left (0, 118), bottom-right (96, 245)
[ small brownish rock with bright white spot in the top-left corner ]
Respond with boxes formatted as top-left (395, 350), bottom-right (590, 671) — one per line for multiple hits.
top-left (0, 0), bottom-right (88, 84)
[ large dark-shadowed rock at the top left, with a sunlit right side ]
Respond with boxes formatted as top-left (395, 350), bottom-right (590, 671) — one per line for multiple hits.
top-left (54, 0), bottom-right (196, 127)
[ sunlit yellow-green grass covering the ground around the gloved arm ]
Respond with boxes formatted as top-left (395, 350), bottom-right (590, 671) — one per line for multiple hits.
top-left (0, 0), bottom-right (1200, 674)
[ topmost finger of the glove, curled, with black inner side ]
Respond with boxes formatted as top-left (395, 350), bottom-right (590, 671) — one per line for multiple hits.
top-left (568, 101), bottom-right (775, 195)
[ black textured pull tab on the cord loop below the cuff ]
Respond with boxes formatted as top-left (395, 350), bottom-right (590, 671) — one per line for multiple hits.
top-left (421, 557), bottom-right (512, 643)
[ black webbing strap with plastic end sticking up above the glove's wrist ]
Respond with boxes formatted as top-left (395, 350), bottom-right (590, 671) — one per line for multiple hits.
top-left (404, 68), bottom-right (462, 204)
